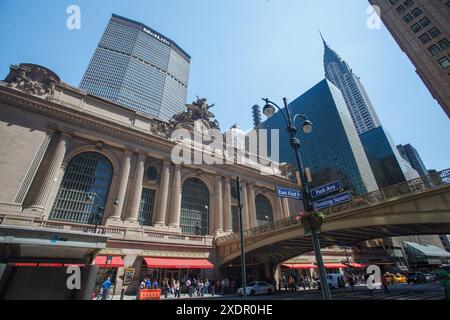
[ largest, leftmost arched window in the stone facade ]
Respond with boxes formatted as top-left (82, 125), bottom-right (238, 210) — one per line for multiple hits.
top-left (49, 152), bottom-right (113, 224)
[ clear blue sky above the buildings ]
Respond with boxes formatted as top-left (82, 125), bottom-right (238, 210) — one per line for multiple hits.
top-left (0, 0), bottom-right (450, 170)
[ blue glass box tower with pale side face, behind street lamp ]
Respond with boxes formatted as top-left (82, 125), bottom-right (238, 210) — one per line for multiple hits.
top-left (258, 80), bottom-right (378, 195)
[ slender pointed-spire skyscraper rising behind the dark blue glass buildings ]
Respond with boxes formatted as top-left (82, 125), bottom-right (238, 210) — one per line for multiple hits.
top-left (322, 37), bottom-right (381, 134)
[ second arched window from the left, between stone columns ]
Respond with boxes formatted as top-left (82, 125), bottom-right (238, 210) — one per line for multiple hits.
top-left (180, 178), bottom-right (209, 236)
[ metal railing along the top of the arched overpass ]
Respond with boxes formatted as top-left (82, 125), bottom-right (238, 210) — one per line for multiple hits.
top-left (215, 169), bottom-right (450, 244)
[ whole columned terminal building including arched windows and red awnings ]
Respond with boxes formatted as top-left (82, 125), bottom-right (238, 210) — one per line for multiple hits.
top-left (0, 64), bottom-right (322, 298)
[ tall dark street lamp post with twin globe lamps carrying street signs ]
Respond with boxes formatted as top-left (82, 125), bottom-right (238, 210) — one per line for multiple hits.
top-left (263, 98), bottom-right (331, 300)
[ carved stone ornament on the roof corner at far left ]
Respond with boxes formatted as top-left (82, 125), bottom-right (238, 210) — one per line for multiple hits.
top-left (5, 63), bottom-right (61, 100)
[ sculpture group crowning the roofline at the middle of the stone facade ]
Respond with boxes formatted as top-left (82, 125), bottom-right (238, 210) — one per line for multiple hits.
top-left (170, 97), bottom-right (220, 131)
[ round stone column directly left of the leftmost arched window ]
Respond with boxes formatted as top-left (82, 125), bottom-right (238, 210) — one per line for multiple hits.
top-left (30, 133), bottom-right (70, 210)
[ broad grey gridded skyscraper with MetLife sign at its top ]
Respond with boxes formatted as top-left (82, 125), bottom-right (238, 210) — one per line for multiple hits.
top-left (80, 14), bottom-right (191, 121)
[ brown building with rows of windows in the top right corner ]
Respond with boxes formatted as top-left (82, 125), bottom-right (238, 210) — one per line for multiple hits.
top-left (369, 0), bottom-right (450, 117)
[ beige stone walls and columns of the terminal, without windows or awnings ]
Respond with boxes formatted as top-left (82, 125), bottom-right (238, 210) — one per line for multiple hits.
top-left (0, 64), bottom-right (302, 298)
